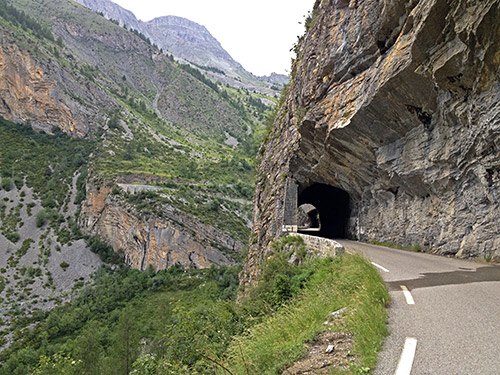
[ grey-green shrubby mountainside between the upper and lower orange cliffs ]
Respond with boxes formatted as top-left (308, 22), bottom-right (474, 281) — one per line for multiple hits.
top-left (0, 0), bottom-right (267, 244)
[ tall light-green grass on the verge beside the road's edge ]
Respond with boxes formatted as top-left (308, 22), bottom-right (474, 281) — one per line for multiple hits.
top-left (229, 255), bottom-right (389, 374)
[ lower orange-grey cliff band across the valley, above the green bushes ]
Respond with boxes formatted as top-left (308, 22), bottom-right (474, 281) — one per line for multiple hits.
top-left (79, 178), bottom-right (244, 271)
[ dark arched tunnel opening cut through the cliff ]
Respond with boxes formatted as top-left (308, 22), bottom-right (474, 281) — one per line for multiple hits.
top-left (297, 183), bottom-right (351, 238)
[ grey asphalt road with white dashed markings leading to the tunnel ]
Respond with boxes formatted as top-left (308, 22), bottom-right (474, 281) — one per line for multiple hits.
top-left (338, 241), bottom-right (500, 375)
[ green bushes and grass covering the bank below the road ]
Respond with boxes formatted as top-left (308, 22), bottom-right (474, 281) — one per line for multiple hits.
top-left (0, 239), bottom-right (388, 375)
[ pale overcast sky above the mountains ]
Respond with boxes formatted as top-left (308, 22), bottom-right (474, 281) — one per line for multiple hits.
top-left (112, 0), bottom-right (314, 76)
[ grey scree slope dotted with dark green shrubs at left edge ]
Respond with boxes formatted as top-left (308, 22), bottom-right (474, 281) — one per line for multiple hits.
top-left (0, 119), bottom-right (102, 348)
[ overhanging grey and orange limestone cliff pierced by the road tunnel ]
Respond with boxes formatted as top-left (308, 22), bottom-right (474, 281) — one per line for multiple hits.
top-left (244, 0), bottom-right (500, 282)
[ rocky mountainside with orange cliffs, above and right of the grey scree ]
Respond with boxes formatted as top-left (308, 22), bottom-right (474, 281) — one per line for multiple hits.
top-left (0, 0), bottom-right (268, 276)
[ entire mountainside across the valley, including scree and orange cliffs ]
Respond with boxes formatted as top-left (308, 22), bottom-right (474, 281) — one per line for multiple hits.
top-left (0, 0), bottom-right (274, 352)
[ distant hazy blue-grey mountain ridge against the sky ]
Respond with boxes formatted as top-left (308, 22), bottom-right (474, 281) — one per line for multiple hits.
top-left (75, 0), bottom-right (289, 94)
